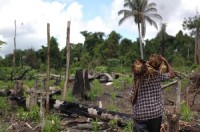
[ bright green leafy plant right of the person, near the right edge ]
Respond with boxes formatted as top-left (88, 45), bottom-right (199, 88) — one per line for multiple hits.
top-left (181, 102), bottom-right (191, 121)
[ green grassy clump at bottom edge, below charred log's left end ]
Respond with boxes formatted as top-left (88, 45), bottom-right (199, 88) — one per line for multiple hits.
top-left (43, 115), bottom-right (61, 132)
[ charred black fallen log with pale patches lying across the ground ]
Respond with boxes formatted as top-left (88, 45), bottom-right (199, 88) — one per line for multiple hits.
top-left (50, 99), bottom-right (132, 126)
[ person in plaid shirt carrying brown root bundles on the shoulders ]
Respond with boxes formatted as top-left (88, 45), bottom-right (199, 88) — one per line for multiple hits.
top-left (131, 54), bottom-right (175, 132)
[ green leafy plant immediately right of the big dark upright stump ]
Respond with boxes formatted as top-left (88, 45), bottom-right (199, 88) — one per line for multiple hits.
top-left (87, 79), bottom-right (103, 100)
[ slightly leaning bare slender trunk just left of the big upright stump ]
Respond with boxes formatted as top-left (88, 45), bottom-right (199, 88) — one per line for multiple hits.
top-left (62, 21), bottom-right (71, 100)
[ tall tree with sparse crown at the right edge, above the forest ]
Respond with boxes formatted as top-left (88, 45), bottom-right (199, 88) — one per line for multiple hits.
top-left (183, 12), bottom-right (200, 64)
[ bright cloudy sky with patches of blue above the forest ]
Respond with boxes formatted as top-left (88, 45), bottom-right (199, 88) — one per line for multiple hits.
top-left (0, 0), bottom-right (200, 56)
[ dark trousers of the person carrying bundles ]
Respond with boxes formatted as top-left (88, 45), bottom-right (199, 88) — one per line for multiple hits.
top-left (134, 116), bottom-right (162, 132)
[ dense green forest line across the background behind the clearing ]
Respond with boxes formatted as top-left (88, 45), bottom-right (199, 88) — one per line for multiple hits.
top-left (0, 31), bottom-right (195, 76)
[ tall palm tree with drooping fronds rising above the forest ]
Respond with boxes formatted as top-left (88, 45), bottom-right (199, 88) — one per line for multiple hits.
top-left (118, 0), bottom-right (162, 59)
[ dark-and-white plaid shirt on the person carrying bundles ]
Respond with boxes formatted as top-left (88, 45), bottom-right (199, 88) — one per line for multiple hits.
top-left (132, 73), bottom-right (170, 120)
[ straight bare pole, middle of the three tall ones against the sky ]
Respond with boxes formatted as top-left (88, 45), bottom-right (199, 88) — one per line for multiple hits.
top-left (46, 23), bottom-right (50, 113)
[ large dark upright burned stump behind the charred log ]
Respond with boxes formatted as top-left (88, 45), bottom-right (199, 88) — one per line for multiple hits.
top-left (72, 70), bottom-right (90, 97)
